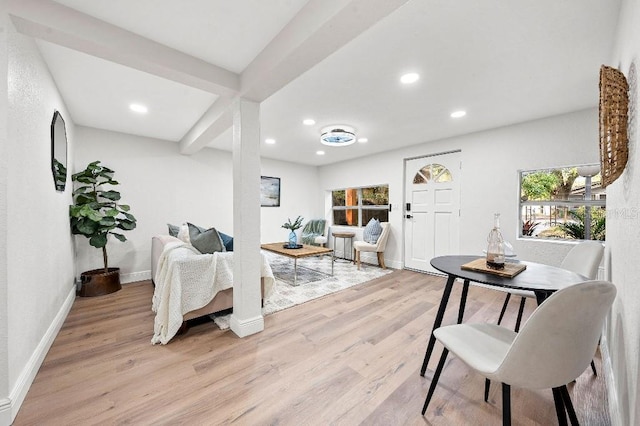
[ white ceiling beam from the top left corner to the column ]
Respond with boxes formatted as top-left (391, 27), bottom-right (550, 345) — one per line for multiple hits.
top-left (8, 0), bottom-right (240, 97)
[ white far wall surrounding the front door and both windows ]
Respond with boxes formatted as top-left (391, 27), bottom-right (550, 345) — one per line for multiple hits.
top-left (320, 109), bottom-right (598, 268)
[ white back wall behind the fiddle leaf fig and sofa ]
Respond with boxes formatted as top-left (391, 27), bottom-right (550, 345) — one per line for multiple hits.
top-left (75, 126), bottom-right (322, 283)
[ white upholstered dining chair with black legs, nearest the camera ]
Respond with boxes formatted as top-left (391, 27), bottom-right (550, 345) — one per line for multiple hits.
top-left (422, 281), bottom-right (616, 425)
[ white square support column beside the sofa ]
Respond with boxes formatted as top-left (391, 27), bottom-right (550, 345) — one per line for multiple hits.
top-left (230, 99), bottom-right (264, 337)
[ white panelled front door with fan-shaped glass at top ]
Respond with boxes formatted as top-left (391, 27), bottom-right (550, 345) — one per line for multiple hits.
top-left (404, 151), bottom-right (462, 272)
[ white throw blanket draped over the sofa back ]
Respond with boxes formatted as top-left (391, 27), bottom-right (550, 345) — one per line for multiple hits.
top-left (151, 243), bottom-right (275, 344)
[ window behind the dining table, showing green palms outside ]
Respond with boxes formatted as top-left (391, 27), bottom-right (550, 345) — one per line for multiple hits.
top-left (519, 164), bottom-right (606, 240)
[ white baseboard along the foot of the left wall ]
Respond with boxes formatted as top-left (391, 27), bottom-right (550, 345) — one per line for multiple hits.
top-left (9, 285), bottom-right (76, 424)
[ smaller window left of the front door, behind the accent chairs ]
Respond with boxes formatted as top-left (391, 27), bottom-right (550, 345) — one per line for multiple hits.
top-left (331, 185), bottom-right (389, 226)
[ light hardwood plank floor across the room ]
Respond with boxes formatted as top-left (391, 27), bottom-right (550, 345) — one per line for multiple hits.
top-left (14, 271), bottom-right (609, 426)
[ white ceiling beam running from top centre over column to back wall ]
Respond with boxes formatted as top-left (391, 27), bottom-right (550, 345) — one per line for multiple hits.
top-left (180, 0), bottom-right (409, 154)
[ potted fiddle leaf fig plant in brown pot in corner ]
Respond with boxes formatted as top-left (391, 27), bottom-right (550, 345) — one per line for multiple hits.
top-left (69, 161), bottom-right (136, 296)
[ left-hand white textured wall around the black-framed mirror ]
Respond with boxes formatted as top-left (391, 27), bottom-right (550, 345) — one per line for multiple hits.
top-left (0, 16), bottom-right (75, 422)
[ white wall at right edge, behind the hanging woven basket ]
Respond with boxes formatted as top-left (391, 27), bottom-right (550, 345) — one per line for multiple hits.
top-left (603, 0), bottom-right (640, 425)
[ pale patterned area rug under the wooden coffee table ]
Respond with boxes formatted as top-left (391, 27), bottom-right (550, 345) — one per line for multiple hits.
top-left (212, 251), bottom-right (392, 330)
